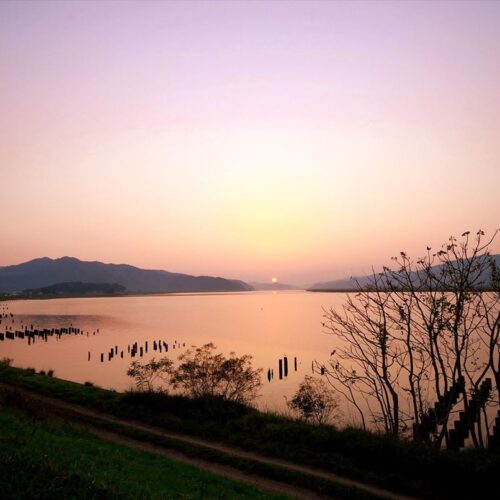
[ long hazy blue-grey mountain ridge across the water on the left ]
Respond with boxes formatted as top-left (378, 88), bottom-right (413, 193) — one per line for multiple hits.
top-left (0, 257), bottom-right (252, 293)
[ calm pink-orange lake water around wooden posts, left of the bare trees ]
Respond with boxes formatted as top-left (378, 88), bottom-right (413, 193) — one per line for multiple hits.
top-left (0, 292), bottom-right (346, 410)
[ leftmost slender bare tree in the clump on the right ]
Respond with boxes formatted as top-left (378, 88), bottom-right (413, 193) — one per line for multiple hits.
top-left (324, 274), bottom-right (400, 434)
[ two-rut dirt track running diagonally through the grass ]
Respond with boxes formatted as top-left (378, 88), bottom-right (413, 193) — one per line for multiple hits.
top-left (0, 382), bottom-right (411, 500)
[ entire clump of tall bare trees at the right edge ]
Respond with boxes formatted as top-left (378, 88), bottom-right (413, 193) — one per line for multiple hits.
top-left (318, 231), bottom-right (500, 448)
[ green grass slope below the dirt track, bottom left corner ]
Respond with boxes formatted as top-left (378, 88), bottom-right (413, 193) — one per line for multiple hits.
top-left (0, 407), bottom-right (285, 499)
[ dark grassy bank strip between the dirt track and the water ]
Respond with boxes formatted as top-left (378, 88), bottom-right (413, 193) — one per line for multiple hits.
top-left (0, 366), bottom-right (500, 498)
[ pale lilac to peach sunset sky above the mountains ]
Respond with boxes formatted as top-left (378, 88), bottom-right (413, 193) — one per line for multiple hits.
top-left (0, 0), bottom-right (500, 284)
